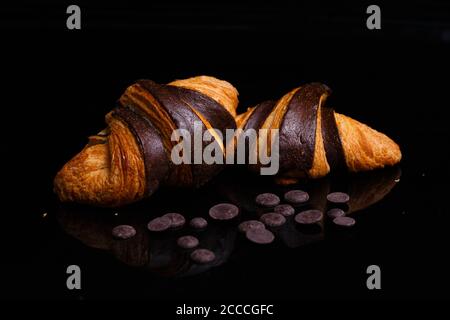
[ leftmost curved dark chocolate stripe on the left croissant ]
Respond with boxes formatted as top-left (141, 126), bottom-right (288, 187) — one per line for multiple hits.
top-left (113, 106), bottom-right (169, 195)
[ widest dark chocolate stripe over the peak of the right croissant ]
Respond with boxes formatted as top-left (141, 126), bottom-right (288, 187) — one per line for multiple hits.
top-left (280, 83), bottom-right (330, 171)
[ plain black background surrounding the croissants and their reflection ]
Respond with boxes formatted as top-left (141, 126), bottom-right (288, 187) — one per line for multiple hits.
top-left (0, 1), bottom-right (450, 302)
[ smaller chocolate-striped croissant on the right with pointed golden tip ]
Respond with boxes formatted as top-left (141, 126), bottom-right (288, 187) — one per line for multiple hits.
top-left (236, 83), bottom-right (401, 183)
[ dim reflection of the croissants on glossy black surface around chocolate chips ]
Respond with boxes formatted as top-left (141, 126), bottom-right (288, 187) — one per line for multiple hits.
top-left (53, 168), bottom-right (401, 276)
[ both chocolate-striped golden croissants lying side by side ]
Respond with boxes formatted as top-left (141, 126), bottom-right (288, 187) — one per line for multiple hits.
top-left (54, 76), bottom-right (401, 207)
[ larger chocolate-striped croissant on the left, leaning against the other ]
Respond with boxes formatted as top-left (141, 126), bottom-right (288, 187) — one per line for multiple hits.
top-left (54, 76), bottom-right (238, 207)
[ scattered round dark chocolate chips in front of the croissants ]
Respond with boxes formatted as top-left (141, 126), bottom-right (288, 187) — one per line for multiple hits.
top-left (112, 190), bottom-right (355, 264)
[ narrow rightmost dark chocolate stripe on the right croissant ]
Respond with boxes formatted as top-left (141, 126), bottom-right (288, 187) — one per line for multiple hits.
top-left (321, 107), bottom-right (347, 170)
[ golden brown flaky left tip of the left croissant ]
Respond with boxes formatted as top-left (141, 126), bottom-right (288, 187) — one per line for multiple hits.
top-left (54, 115), bottom-right (145, 206)
